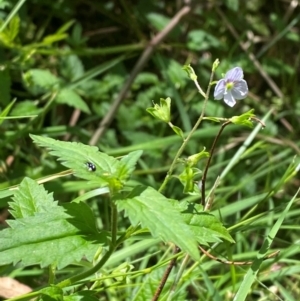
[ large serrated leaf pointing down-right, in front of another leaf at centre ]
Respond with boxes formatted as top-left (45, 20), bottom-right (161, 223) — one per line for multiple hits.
top-left (116, 187), bottom-right (199, 260)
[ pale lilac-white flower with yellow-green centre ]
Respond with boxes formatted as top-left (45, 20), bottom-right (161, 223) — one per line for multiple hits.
top-left (214, 67), bottom-right (248, 107)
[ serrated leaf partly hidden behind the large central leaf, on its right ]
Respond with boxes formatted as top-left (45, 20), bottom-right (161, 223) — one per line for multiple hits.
top-left (174, 201), bottom-right (235, 246)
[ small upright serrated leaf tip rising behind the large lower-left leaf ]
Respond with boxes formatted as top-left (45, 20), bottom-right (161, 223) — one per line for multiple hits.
top-left (9, 178), bottom-right (57, 218)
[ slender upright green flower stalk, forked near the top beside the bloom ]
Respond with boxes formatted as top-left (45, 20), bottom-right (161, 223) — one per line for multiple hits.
top-left (158, 70), bottom-right (214, 192)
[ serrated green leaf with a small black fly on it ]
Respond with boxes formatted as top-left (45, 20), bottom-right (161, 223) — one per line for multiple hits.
top-left (30, 135), bottom-right (137, 190)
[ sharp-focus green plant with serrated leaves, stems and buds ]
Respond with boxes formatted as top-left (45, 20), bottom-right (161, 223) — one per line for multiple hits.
top-left (0, 59), bottom-right (290, 296)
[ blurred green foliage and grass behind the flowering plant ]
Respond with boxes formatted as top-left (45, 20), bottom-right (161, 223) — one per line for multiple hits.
top-left (0, 0), bottom-right (300, 300)
